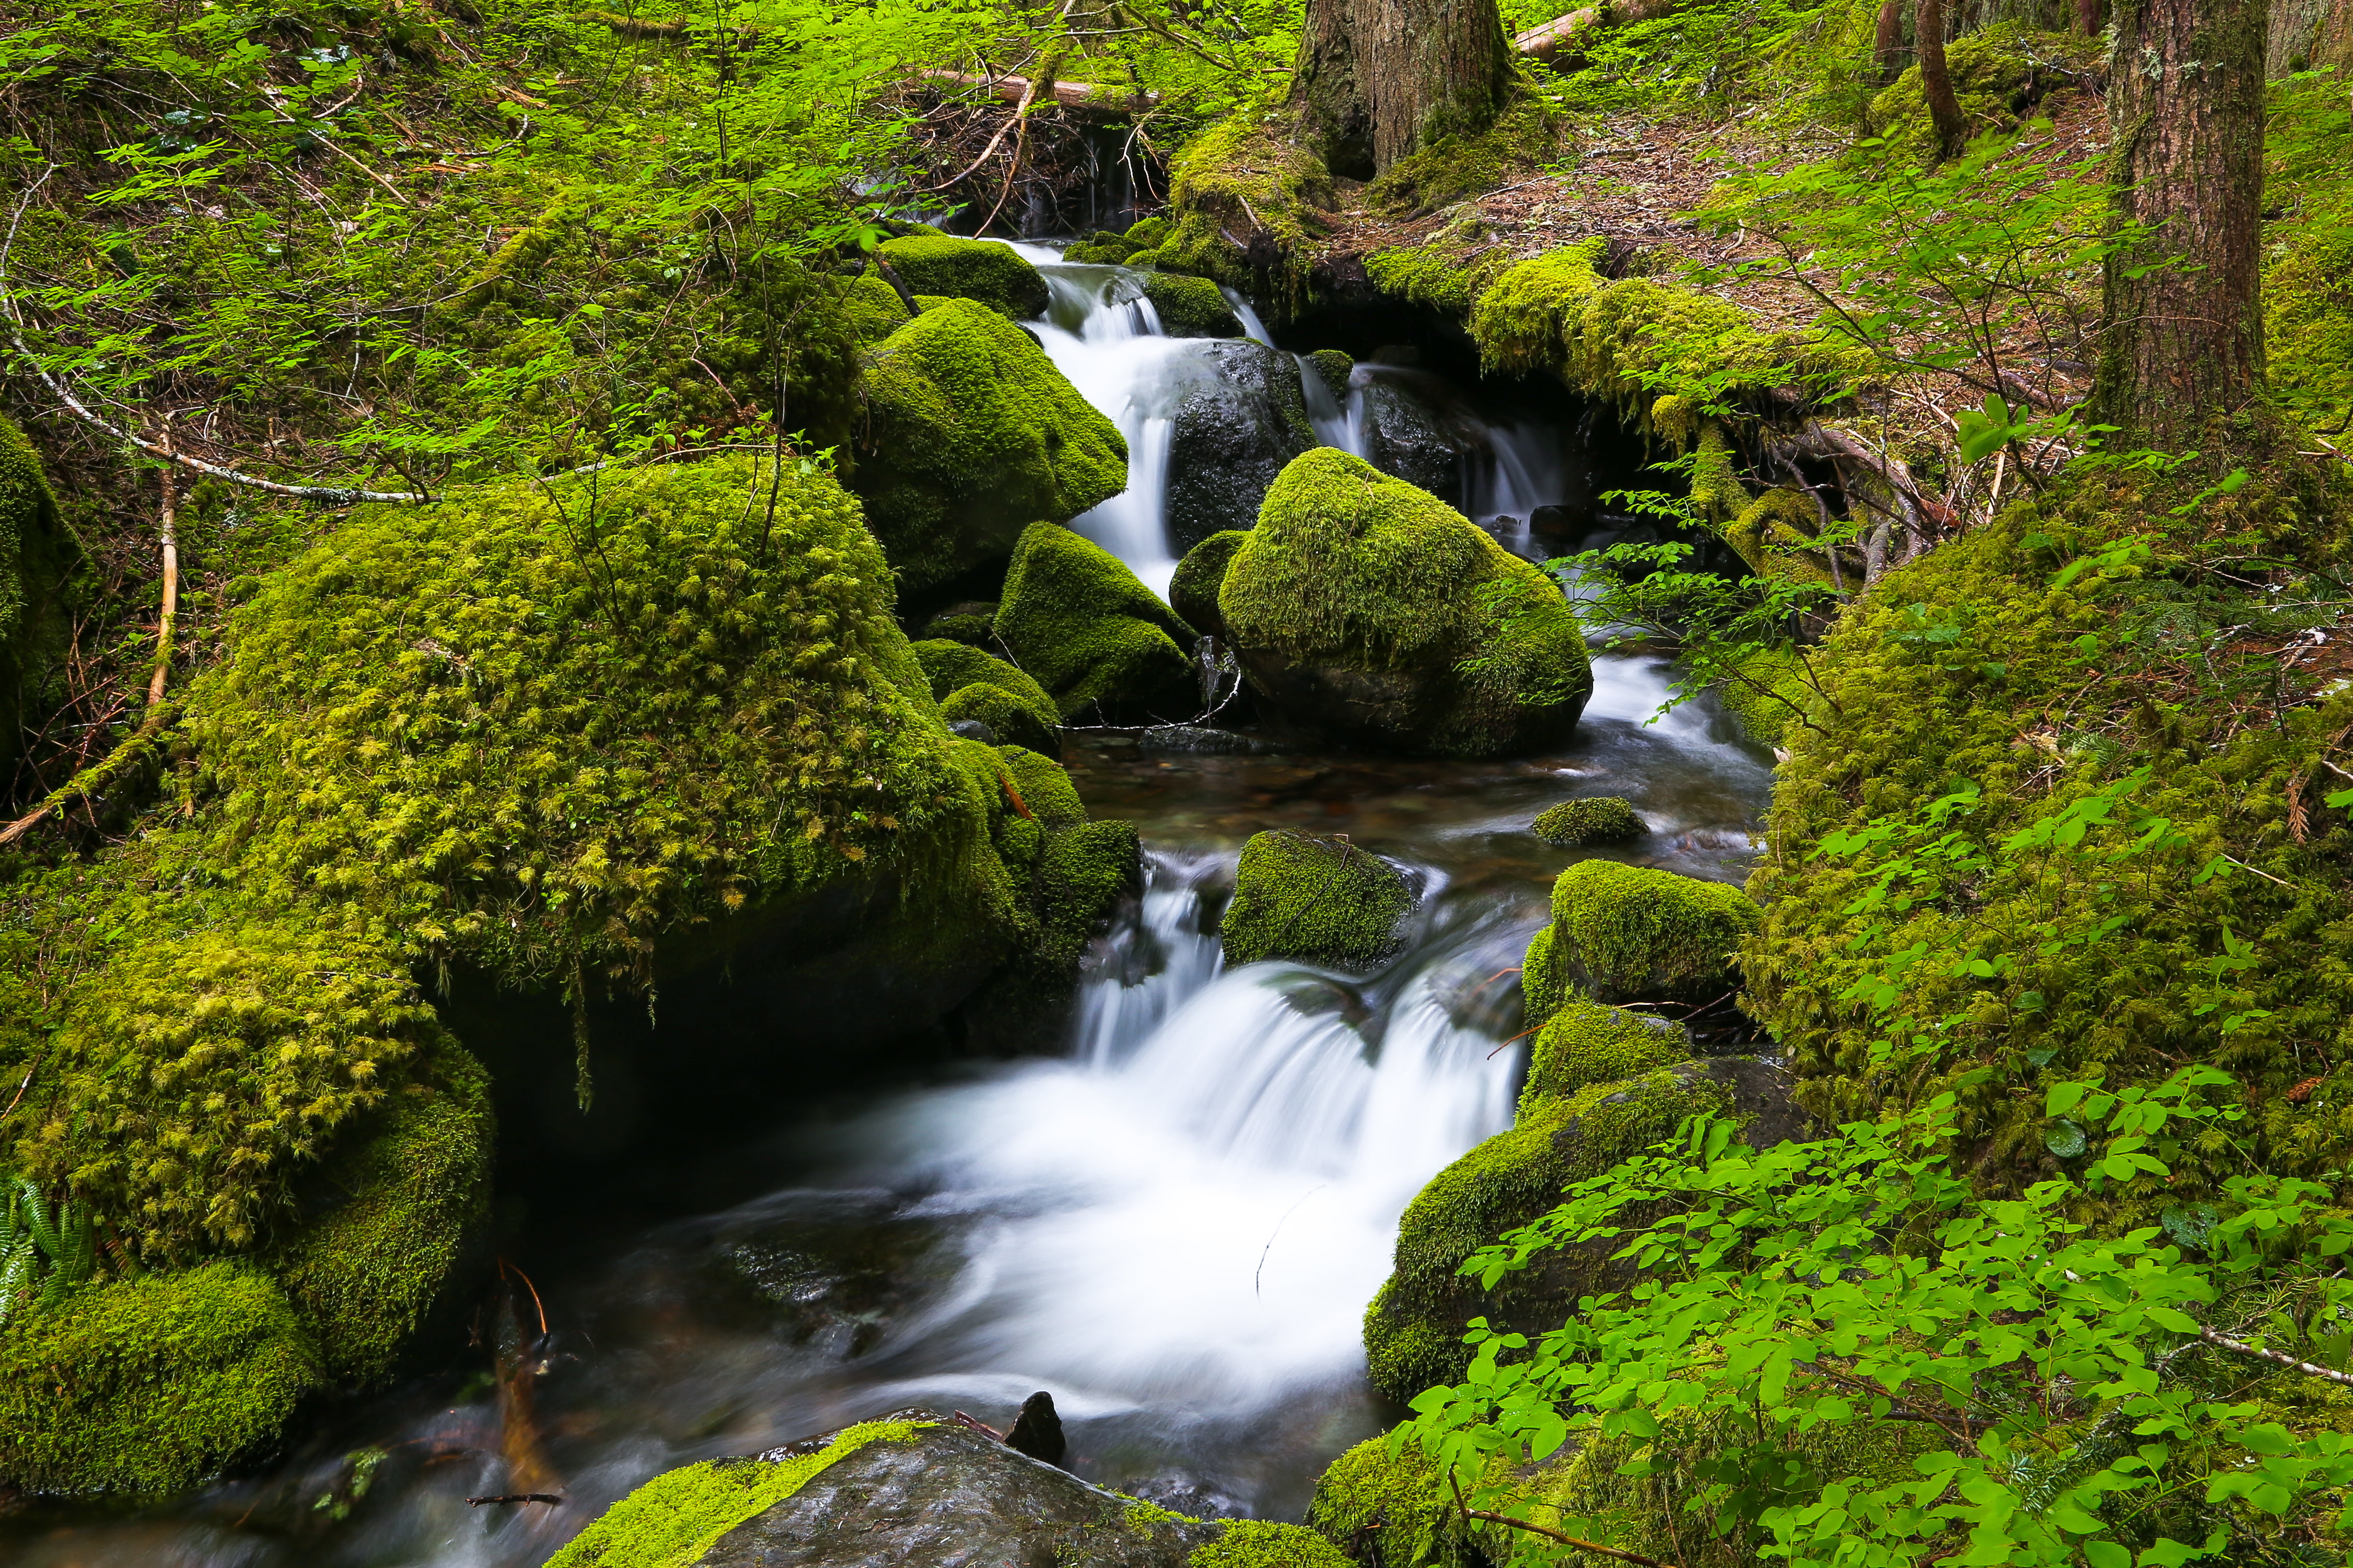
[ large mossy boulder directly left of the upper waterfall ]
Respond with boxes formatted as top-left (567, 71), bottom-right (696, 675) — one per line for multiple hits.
top-left (849, 300), bottom-right (1127, 590)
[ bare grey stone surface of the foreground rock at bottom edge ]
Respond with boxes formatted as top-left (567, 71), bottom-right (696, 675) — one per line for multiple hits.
top-left (694, 1411), bottom-right (1226, 1568)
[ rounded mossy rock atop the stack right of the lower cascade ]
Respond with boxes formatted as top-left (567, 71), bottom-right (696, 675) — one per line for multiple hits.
top-left (1553, 860), bottom-right (1758, 1006)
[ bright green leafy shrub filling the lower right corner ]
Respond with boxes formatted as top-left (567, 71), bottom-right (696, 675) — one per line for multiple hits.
top-left (1409, 1067), bottom-right (2353, 1568)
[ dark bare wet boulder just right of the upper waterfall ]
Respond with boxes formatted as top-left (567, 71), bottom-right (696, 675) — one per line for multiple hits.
top-left (1165, 341), bottom-right (1315, 555)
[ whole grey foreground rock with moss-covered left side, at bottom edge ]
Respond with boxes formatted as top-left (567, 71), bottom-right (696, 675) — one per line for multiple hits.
top-left (548, 1411), bottom-right (1348, 1568)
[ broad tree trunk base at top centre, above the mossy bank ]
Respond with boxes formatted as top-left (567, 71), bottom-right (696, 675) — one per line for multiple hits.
top-left (1292, 0), bottom-right (1513, 179)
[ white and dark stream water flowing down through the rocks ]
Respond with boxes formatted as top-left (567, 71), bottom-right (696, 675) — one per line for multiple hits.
top-left (0, 249), bottom-right (1770, 1568)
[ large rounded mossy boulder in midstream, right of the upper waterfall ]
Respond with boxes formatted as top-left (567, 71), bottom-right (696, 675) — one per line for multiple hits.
top-left (1219, 447), bottom-right (1593, 757)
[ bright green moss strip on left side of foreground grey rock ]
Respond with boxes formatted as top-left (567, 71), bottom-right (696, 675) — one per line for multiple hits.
top-left (548, 1420), bottom-right (934, 1568)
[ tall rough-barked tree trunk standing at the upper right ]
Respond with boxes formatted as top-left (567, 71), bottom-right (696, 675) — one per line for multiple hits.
top-left (2092, 0), bottom-right (2266, 449)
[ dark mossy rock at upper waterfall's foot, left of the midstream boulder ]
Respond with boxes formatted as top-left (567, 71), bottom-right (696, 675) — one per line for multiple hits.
top-left (997, 522), bottom-right (1197, 720)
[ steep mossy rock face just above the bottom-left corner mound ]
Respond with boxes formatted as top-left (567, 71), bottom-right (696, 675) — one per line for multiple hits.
top-left (266, 1041), bottom-right (494, 1385)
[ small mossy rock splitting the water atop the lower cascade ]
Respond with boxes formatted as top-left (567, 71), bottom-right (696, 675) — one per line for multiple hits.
top-left (1219, 830), bottom-right (1414, 969)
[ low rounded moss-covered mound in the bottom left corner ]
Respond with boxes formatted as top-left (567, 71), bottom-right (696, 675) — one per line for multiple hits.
top-left (0, 1262), bottom-right (320, 1493)
